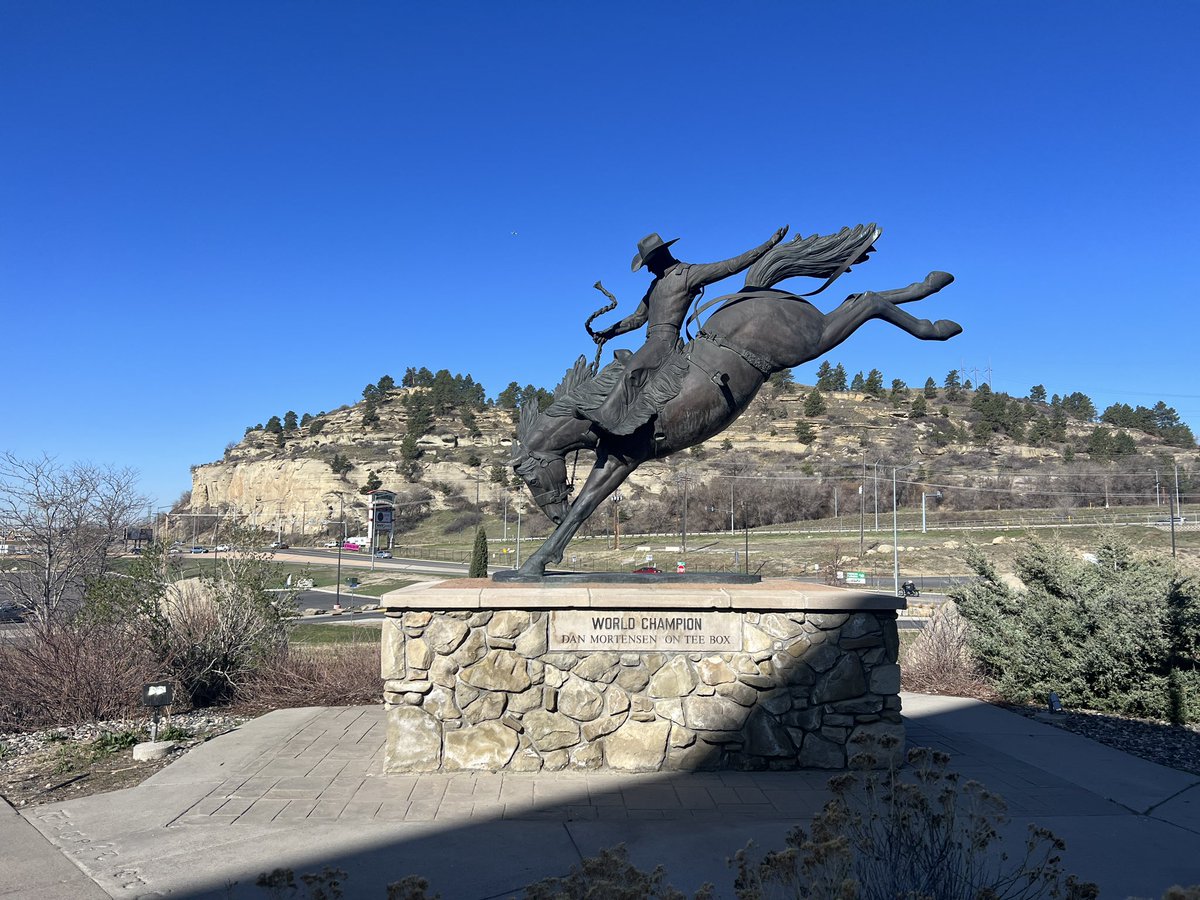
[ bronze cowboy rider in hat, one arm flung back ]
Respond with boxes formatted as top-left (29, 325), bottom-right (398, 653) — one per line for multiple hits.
top-left (582, 226), bottom-right (787, 434)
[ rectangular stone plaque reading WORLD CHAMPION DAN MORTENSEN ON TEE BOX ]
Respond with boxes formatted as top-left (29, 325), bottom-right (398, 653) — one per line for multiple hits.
top-left (550, 610), bottom-right (742, 653)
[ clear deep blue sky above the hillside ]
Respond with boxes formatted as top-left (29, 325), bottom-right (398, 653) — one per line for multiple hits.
top-left (0, 0), bottom-right (1200, 503)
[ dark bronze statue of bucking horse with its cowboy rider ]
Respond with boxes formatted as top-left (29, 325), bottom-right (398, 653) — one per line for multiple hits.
top-left (501, 224), bottom-right (962, 577)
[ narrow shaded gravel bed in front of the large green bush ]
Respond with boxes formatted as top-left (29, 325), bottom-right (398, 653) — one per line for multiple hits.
top-left (1007, 706), bottom-right (1200, 775)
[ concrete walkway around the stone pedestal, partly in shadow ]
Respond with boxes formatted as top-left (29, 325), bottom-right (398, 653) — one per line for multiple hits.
top-left (0, 695), bottom-right (1200, 900)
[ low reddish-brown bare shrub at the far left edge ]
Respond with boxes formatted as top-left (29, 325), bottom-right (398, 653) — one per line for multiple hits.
top-left (0, 626), bottom-right (162, 732)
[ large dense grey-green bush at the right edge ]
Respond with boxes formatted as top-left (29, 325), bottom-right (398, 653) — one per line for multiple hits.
top-left (950, 539), bottom-right (1200, 721)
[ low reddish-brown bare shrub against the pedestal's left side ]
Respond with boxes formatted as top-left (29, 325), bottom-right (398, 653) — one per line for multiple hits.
top-left (239, 642), bottom-right (382, 707)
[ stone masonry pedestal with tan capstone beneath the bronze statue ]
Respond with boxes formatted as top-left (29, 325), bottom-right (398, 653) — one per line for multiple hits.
top-left (382, 580), bottom-right (904, 773)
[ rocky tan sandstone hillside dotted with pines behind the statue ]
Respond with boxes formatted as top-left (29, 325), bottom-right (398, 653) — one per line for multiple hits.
top-left (176, 364), bottom-right (1198, 549)
